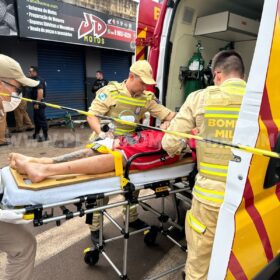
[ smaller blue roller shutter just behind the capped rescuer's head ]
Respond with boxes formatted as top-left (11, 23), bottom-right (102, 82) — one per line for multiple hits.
top-left (101, 50), bottom-right (132, 82)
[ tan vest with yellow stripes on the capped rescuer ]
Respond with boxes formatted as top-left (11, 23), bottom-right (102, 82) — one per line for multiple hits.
top-left (106, 82), bottom-right (154, 135)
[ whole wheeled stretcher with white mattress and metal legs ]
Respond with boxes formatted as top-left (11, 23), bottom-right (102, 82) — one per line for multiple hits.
top-left (1, 153), bottom-right (194, 279)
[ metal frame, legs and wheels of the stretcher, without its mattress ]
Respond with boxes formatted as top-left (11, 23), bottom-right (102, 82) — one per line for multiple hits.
top-left (8, 151), bottom-right (192, 280)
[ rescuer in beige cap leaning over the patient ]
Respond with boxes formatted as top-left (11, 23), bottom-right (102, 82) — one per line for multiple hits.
top-left (88, 60), bottom-right (175, 242)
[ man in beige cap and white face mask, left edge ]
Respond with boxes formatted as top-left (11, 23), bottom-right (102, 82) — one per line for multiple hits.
top-left (0, 55), bottom-right (39, 280)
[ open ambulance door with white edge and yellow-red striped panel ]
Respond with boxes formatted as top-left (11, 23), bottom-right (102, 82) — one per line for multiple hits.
top-left (211, 0), bottom-right (280, 280)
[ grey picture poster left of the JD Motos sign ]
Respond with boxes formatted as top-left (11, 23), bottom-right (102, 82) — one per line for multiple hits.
top-left (0, 0), bottom-right (17, 36)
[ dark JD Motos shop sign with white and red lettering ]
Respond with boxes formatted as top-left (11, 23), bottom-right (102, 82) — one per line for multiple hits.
top-left (17, 0), bottom-right (136, 52)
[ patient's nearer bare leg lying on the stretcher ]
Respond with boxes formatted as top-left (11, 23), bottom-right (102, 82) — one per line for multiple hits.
top-left (16, 154), bottom-right (126, 183)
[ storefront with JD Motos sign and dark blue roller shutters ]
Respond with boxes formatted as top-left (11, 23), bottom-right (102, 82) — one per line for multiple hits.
top-left (0, 0), bottom-right (136, 118)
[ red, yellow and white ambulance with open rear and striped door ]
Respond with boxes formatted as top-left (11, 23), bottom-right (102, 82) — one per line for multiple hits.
top-left (140, 0), bottom-right (280, 280)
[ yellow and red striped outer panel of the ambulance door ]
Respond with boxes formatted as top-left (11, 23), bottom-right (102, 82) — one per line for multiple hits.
top-left (226, 1), bottom-right (280, 280)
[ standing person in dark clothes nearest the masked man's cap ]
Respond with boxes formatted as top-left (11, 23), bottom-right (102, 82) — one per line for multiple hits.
top-left (29, 66), bottom-right (49, 142)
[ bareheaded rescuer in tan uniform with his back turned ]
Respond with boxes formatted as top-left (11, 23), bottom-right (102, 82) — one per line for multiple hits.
top-left (162, 50), bottom-right (246, 280)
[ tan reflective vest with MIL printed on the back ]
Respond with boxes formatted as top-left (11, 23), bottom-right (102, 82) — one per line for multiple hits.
top-left (194, 79), bottom-right (246, 183)
